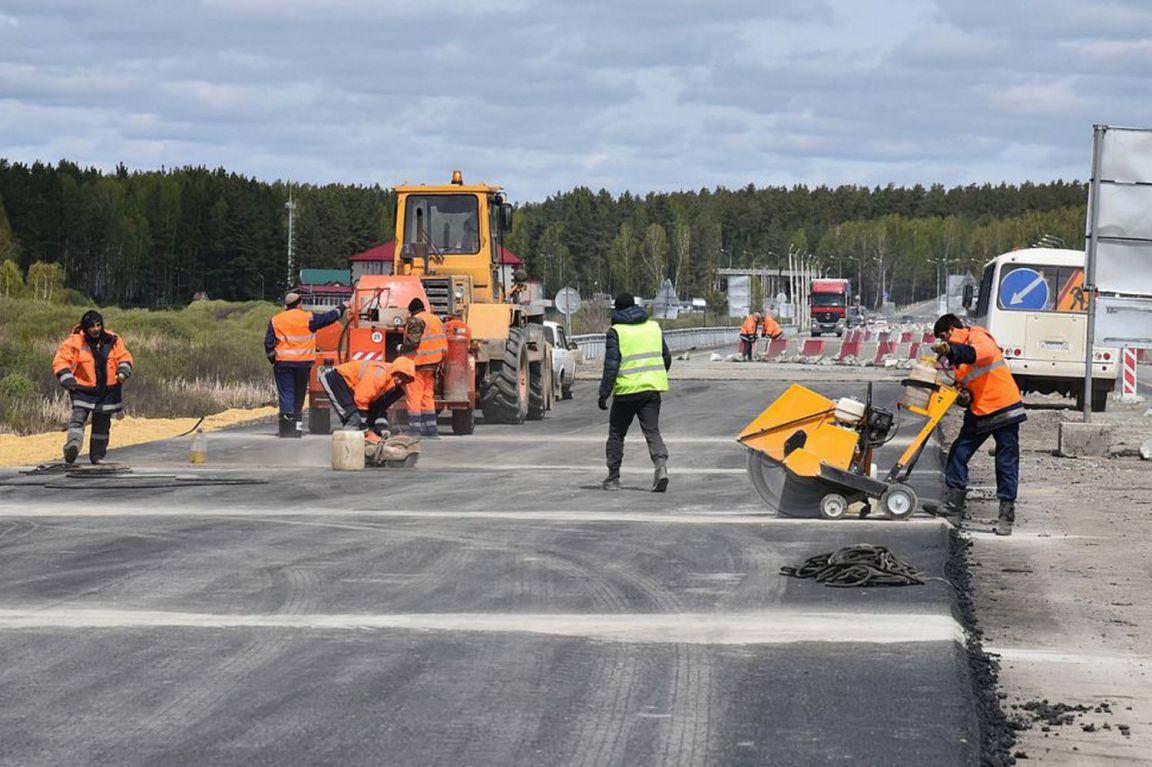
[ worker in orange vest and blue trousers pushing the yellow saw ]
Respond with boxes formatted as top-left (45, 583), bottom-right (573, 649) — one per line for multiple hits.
top-left (932, 314), bottom-right (1028, 536)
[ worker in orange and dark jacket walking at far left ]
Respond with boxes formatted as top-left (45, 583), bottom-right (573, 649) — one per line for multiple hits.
top-left (52, 310), bottom-right (132, 463)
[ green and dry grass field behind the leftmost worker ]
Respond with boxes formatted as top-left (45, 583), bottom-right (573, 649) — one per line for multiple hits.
top-left (0, 298), bottom-right (279, 434)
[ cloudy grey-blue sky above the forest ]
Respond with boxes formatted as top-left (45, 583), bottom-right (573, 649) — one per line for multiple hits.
top-left (0, 0), bottom-right (1152, 202)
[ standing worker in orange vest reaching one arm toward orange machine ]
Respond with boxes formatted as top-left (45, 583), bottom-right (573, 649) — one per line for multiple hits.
top-left (264, 293), bottom-right (346, 436)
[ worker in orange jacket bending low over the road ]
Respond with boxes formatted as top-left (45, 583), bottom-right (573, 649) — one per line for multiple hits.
top-left (320, 357), bottom-right (416, 435)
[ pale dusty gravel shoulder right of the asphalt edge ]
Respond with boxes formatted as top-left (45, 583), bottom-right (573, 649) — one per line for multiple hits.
top-left (945, 397), bottom-right (1152, 765)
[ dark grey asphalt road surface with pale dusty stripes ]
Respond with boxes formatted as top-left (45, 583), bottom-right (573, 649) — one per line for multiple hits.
top-left (0, 369), bottom-right (979, 766)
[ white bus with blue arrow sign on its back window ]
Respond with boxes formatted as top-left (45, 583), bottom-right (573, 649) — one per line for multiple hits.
top-left (964, 248), bottom-right (1120, 411)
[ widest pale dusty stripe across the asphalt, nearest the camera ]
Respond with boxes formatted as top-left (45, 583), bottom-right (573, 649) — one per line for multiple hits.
top-left (0, 607), bottom-right (964, 645)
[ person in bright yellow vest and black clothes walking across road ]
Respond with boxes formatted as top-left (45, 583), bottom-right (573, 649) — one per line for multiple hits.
top-left (598, 293), bottom-right (672, 493)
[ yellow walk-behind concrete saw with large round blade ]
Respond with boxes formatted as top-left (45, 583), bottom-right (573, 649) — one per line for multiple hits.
top-left (736, 359), bottom-right (968, 519)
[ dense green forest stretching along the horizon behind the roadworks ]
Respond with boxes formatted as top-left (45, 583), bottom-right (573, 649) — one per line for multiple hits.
top-left (0, 159), bottom-right (1086, 307)
